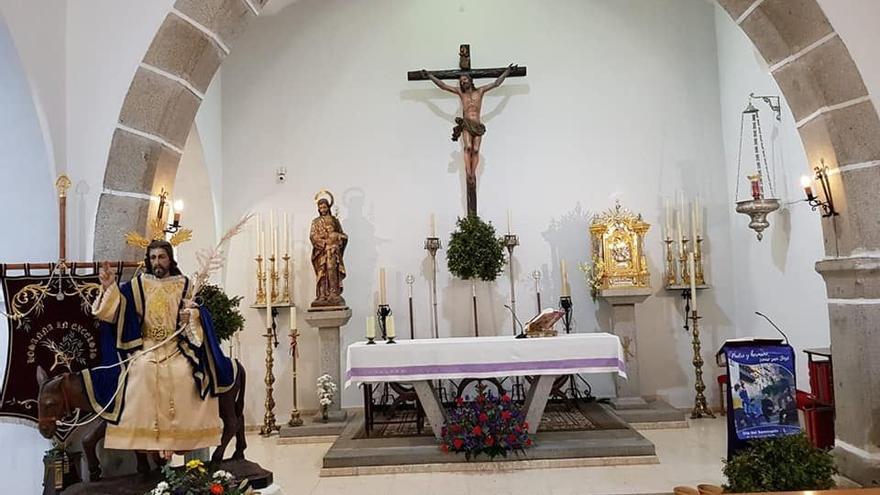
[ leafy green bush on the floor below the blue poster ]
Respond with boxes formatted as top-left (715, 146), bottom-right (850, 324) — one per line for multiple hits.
top-left (724, 434), bottom-right (837, 493)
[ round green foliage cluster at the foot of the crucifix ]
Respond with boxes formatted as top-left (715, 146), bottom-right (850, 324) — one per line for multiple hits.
top-left (446, 215), bottom-right (504, 282)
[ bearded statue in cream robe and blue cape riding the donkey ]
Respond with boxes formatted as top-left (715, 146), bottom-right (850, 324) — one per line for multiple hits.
top-left (83, 240), bottom-right (238, 458)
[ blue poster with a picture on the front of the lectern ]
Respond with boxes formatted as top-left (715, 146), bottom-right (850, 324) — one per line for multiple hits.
top-left (726, 345), bottom-right (800, 440)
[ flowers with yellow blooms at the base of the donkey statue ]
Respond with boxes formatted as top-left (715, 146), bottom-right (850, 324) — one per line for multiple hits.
top-left (147, 459), bottom-right (254, 495)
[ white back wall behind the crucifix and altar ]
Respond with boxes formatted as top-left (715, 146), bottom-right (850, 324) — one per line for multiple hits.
top-left (215, 1), bottom-right (734, 422)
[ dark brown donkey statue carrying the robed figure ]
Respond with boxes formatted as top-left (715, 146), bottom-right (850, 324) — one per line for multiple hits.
top-left (37, 363), bottom-right (247, 481)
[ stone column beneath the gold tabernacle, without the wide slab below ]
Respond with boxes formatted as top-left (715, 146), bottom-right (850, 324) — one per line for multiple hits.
top-left (599, 288), bottom-right (651, 409)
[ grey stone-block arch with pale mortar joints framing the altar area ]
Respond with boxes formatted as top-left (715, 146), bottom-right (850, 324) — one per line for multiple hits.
top-left (94, 0), bottom-right (880, 484)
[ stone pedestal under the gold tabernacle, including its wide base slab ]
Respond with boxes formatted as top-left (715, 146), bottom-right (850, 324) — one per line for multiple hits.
top-left (599, 288), bottom-right (687, 426)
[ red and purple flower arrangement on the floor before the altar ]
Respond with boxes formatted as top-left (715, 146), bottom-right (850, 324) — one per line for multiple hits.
top-left (440, 390), bottom-right (532, 460)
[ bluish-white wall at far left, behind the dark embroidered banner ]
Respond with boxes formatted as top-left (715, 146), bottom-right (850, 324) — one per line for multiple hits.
top-left (0, 19), bottom-right (58, 493)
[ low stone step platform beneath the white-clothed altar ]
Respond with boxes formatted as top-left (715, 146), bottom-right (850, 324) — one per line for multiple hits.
top-left (321, 404), bottom-right (658, 476)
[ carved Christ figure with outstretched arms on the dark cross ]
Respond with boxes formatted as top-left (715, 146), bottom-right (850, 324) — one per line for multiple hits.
top-left (422, 64), bottom-right (517, 215)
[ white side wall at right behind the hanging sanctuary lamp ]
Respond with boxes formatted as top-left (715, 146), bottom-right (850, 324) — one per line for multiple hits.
top-left (715, 7), bottom-right (830, 390)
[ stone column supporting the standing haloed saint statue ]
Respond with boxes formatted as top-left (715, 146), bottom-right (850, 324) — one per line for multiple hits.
top-left (305, 308), bottom-right (351, 421)
